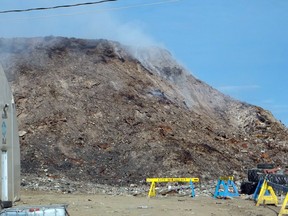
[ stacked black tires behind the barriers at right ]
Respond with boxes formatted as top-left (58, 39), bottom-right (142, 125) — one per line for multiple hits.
top-left (240, 164), bottom-right (288, 195)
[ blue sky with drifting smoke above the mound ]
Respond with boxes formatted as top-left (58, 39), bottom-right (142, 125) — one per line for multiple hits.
top-left (0, 0), bottom-right (288, 125)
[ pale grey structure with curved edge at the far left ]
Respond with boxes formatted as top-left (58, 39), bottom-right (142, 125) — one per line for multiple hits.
top-left (0, 65), bottom-right (20, 202)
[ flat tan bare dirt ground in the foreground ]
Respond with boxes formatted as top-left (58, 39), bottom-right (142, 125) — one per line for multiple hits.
top-left (13, 191), bottom-right (280, 216)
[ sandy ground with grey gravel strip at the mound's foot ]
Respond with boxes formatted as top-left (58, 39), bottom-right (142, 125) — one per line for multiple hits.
top-left (16, 176), bottom-right (281, 216)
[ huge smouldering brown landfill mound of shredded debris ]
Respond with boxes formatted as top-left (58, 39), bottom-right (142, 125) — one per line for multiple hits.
top-left (0, 36), bottom-right (288, 185)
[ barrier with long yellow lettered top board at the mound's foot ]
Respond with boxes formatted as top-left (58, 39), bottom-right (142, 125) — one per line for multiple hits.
top-left (146, 178), bottom-right (199, 197)
